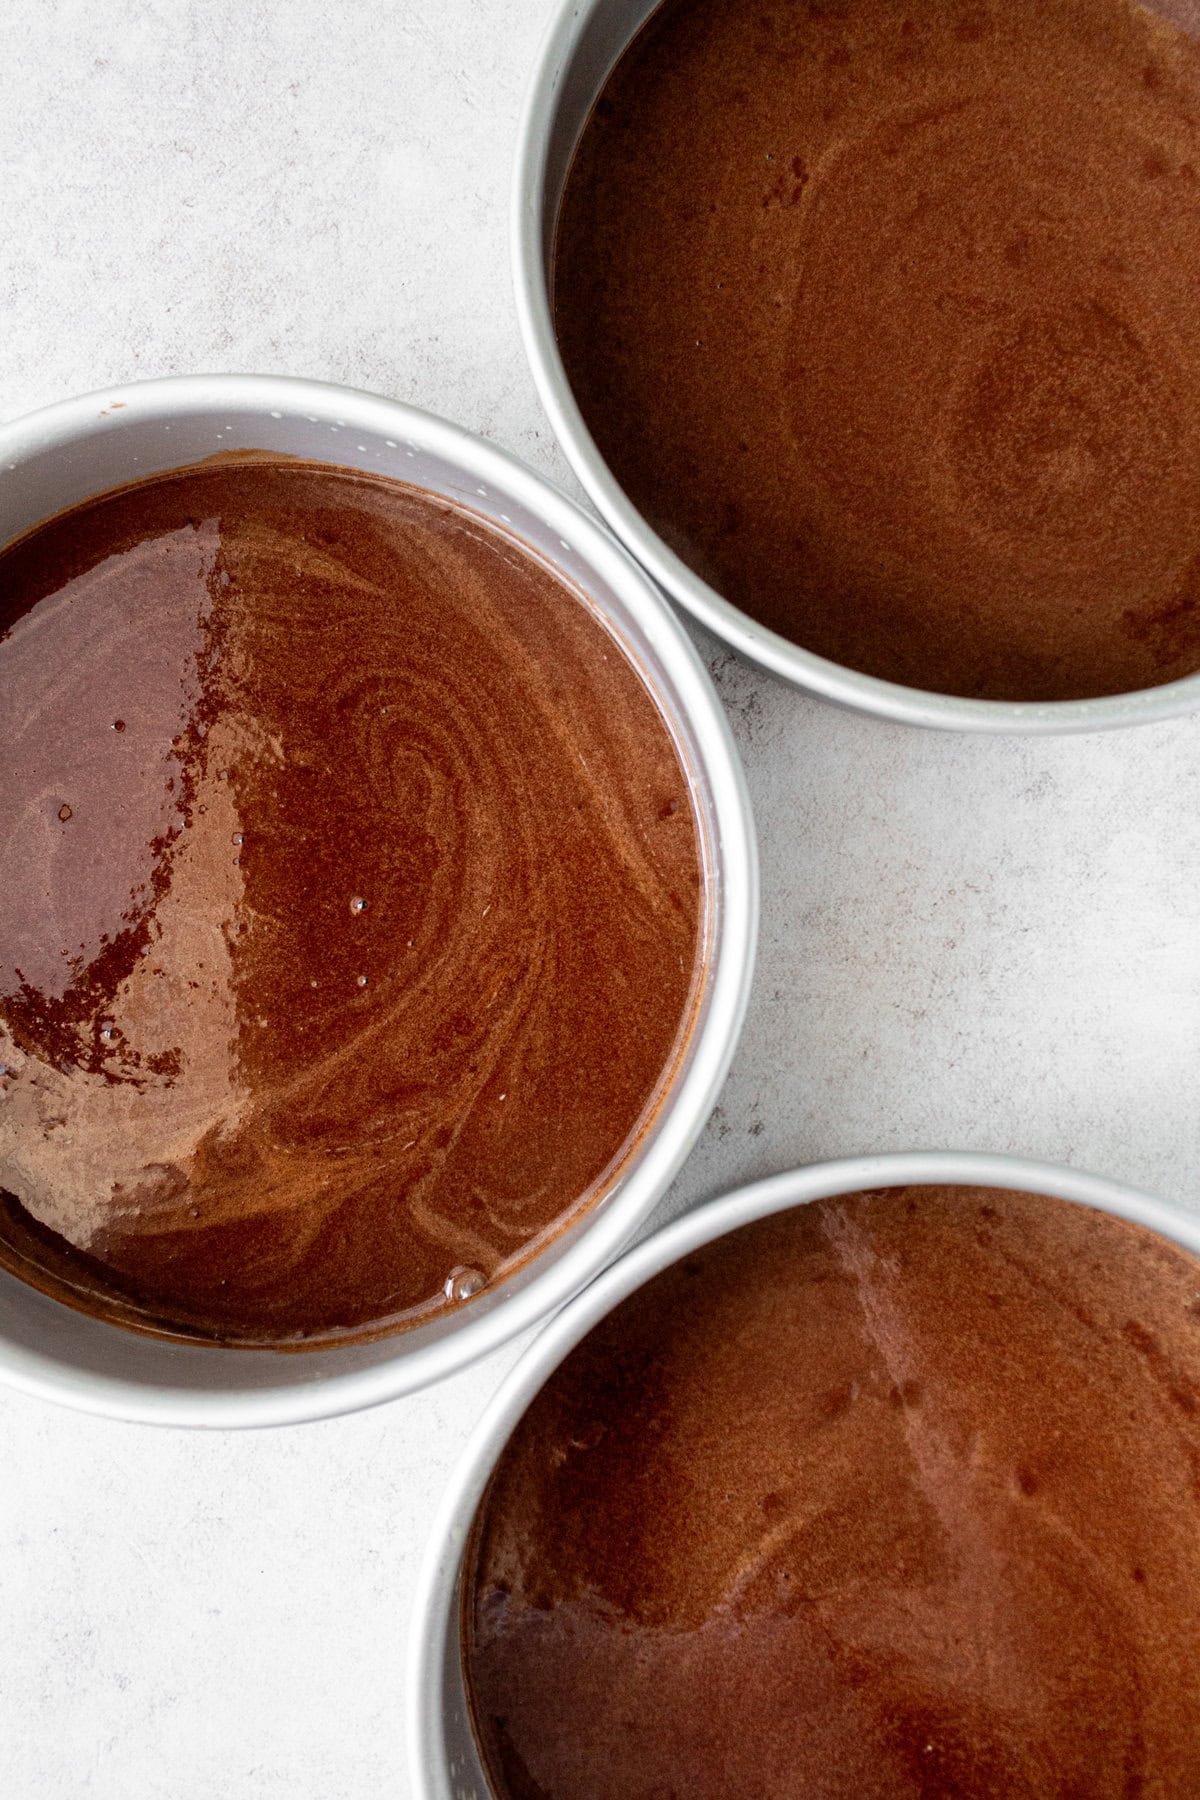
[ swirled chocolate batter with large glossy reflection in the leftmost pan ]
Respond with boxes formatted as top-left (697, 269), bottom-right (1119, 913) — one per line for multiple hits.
top-left (0, 461), bottom-right (702, 1345)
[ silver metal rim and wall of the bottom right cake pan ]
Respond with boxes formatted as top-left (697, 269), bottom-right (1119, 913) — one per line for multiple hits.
top-left (405, 1150), bottom-right (1200, 1800)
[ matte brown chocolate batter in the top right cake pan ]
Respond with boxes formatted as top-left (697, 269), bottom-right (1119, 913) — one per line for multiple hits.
top-left (554, 0), bottom-right (1200, 700)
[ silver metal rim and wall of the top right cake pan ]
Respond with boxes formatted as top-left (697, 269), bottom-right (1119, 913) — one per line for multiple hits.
top-left (513, 0), bottom-right (1200, 734)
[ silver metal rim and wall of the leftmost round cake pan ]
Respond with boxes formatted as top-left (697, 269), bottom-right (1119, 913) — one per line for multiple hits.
top-left (0, 376), bottom-right (757, 1426)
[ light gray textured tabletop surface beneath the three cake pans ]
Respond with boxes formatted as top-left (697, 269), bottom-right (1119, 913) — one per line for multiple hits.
top-left (0, 0), bottom-right (1200, 1800)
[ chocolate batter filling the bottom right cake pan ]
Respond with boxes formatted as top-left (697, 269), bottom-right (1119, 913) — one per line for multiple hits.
top-left (464, 1188), bottom-right (1200, 1800)
